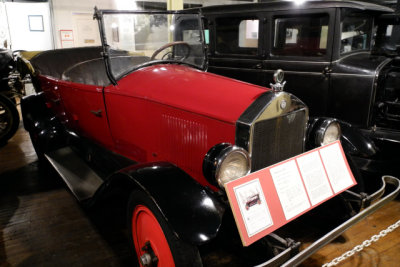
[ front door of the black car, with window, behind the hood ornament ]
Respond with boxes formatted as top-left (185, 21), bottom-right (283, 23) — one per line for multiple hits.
top-left (263, 9), bottom-right (335, 115)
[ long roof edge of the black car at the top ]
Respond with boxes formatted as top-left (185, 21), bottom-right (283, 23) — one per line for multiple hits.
top-left (201, 0), bottom-right (393, 14)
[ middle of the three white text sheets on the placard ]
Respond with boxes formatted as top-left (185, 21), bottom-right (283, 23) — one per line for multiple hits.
top-left (296, 151), bottom-right (333, 206)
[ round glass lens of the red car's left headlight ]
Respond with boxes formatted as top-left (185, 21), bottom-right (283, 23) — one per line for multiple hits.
top-left (216, 146), bottom-right (250, 188)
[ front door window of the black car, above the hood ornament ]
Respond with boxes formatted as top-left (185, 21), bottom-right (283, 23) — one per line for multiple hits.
top-left (272, 14), bottom-right (329, 57)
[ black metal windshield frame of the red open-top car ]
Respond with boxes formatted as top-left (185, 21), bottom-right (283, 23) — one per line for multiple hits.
top-left (93, 7), bottom-right (208, 85)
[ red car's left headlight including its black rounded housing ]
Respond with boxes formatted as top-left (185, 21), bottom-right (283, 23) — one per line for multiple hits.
top-left (203, 144), bottom-right (250, 188)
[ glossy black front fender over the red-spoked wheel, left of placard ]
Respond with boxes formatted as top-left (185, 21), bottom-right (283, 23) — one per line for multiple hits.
top-left (101, 162), bottom-right (226, 245)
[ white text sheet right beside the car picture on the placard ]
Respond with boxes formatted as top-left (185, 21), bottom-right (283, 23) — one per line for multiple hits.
top-left (270, 160), bottom-right (310, 220)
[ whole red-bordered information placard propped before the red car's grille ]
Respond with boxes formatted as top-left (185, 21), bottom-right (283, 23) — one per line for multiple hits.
top-left (225, 141), bottom-right (357, 246)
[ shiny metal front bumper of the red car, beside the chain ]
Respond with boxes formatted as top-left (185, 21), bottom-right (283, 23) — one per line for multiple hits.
top-left (256, 176), bottom-right (400, 267)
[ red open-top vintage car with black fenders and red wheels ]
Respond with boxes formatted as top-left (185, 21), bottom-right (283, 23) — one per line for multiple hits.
top-left (22, 10), bottom-right (400, 266)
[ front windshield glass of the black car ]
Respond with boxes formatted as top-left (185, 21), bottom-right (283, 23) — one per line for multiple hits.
top-left (340, 10), bottom-right (373, 54)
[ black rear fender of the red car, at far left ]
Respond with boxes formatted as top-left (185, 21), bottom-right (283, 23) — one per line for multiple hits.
top-left (21, 92), bottom-right (67, 152)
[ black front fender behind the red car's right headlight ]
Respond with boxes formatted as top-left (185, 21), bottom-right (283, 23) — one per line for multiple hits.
top-left (306, 117), bottom-right (377, 158)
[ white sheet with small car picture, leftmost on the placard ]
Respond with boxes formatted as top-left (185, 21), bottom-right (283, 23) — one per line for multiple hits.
top-left (233, 179), bottom-right (273, 237)
